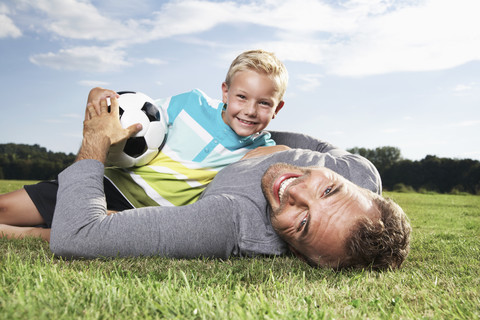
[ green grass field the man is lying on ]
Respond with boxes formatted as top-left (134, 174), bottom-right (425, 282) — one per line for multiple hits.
top-left (0, 181), bottom-right (480, 319)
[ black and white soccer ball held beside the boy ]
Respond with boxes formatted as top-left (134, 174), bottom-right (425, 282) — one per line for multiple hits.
top-left (107, 91), bottom-right (168, 168)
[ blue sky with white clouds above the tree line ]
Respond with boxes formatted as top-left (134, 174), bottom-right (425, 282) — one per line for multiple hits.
top-left (0, 0), bottom-right (480, 160)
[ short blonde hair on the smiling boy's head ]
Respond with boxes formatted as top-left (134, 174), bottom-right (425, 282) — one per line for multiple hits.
top-left (225, 50), bottom-right (288, 100)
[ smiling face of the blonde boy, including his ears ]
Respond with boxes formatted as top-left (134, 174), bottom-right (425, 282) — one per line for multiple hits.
top-left (222, 70), bottom-right (283, 137)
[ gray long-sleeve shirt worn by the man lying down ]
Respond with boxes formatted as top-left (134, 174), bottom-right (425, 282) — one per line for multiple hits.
top-left (50, 133), bottom-right (381, 258)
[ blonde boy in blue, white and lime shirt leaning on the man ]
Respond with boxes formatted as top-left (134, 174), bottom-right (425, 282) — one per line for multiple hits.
top-left (0, 50), bottom-right (288, 240)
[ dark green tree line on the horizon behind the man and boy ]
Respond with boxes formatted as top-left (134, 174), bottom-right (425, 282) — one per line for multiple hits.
top-left (0, 143), bottom-right (480, 195)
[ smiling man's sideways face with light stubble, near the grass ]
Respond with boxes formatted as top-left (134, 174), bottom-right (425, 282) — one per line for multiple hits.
top-left (262, 163), bottom-right (380, 266)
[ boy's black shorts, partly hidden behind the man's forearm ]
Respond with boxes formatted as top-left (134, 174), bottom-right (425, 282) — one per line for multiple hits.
top-left (24, 178), bottom-right (133, 228)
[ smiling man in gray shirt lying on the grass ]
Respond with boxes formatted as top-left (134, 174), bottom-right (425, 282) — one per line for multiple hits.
top-left (50, 99), bottom-right (410, 268)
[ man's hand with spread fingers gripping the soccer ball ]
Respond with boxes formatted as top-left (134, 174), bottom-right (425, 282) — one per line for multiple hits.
top-left (77, 97), bottom-right (142, 163)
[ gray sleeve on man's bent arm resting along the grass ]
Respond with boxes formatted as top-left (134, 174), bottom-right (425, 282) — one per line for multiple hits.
top-left (50, 160), bottom-right (238, 258)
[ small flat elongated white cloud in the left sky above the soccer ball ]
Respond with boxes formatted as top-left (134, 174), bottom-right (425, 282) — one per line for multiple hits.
top-left (30, 47), bottom-right (130, 72)
